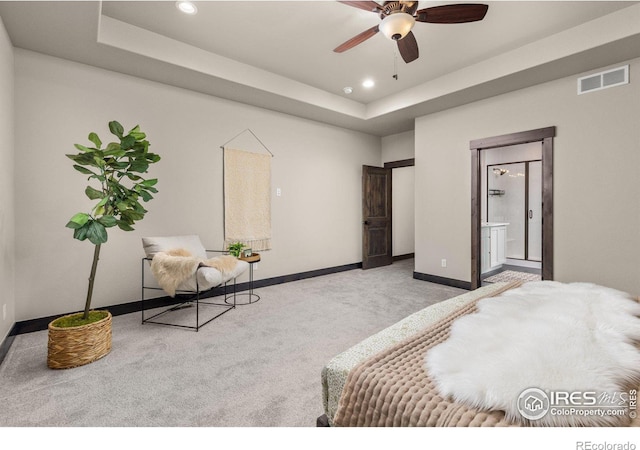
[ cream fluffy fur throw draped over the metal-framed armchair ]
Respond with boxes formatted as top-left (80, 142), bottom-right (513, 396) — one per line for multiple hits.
top-left (151, 249), bottom-right (238, 297)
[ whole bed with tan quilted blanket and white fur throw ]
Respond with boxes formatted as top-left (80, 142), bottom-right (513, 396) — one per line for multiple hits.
top-left (318, 281), bottom-right (640, 427)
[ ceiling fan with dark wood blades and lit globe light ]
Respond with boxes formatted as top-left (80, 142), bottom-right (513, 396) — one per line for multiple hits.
top-left (333, 1), bottom-right (489, 63)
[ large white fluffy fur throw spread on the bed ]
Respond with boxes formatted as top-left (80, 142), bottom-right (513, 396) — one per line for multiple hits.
top-left (425, 281), bottom-right (640, 426)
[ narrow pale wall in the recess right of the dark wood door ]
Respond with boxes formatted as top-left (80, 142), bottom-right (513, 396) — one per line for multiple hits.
top-left (382, 131), bottom-right (415, 256)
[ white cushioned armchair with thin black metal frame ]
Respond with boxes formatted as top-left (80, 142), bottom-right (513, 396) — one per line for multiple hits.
top-left (141, 235), bottom-right (249, 331)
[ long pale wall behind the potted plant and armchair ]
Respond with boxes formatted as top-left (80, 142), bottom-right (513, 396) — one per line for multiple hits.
top-left (15, 50), bottom-right (381, 320)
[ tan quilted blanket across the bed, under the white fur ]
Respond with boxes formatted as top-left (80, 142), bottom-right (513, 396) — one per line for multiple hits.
top-left (334, 282), bottom-right (521, 427)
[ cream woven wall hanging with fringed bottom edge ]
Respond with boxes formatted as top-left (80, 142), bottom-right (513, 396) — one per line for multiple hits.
top-left (224, 148), bottom-right (271, 251)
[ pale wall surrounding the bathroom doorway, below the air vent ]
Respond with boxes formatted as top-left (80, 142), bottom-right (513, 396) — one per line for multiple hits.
top-left (415, 59), bottom-right (640, 295)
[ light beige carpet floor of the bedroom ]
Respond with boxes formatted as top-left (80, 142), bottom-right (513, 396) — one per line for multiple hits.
top-left (0, 260), bottom-right (464, 427)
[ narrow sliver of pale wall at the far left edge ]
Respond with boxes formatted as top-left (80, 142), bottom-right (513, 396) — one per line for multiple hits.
top-left (0, 18), bottom-right (15, 342)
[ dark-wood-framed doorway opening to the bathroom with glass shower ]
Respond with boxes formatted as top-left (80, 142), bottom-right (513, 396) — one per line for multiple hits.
top-left (470, 127), bottom-right (555, 289)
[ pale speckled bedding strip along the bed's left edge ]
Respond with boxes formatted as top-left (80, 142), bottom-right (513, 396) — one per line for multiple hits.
top-left (321, 283), bottom-right (509, 425)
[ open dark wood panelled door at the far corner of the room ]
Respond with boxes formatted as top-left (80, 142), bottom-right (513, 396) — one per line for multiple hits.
top-left (362, 166), bottom-right (393, 269)
